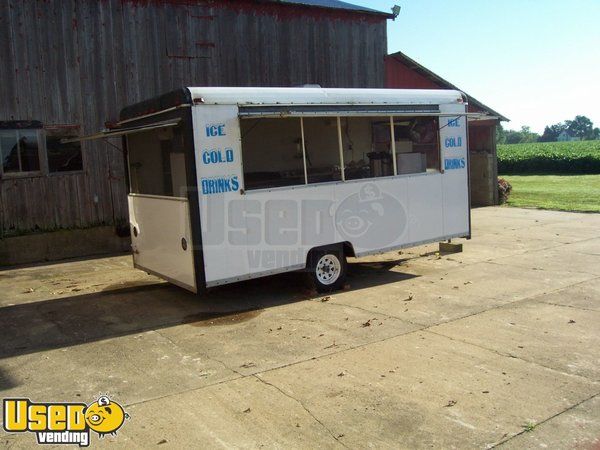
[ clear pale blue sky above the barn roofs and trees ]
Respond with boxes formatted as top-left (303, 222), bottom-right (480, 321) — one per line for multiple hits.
top-left (346, 0), bottom-right (600, 133)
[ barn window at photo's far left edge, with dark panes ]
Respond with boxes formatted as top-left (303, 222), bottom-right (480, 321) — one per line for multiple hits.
top-left (0, 128), bottom-right (40, 175)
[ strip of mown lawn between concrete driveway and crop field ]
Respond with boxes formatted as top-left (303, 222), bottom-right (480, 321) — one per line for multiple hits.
top-left (500, 175), bottom-right (600, 212)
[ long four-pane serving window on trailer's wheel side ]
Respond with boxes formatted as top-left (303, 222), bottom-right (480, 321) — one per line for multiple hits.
top-left (240, 115), bottom-right (440, 190)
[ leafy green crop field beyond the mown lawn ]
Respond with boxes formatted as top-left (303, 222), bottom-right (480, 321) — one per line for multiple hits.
top-left (498, 141), bottom-right (600, 174)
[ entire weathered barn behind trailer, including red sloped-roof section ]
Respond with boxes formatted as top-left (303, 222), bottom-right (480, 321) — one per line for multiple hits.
top-left (0, 0), bottom-right (506, 265)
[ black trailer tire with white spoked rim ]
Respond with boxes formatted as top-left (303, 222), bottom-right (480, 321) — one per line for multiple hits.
top-left (306, 246), bottom-right (347, 292)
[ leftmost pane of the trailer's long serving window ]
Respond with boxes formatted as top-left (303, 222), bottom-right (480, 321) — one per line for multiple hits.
top-left (240, 118), bottom-right (305, 190)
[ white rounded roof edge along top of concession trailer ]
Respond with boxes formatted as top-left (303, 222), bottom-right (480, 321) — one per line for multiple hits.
top-left (188, 87), bottom-right (463, 106)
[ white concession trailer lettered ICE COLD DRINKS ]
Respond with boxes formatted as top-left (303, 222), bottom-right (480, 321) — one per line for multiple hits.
top-left (72, 87), bottom-right (471, 292)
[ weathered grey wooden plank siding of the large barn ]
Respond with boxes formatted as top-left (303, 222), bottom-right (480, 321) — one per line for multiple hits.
top-left (0, 0), bottom-right (387, 234)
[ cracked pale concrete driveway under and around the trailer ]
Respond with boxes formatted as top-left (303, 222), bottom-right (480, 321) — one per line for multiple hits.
top-left (0, 208), bottom-right (600, 449)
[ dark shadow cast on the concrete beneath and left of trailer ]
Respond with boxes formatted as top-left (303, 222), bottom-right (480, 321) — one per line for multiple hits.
top-left (0, 261), bottom-right (415, 358)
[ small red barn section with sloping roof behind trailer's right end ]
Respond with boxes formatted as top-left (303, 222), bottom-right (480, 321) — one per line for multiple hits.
top-left (385, 52), bottom-right (508, 206)
